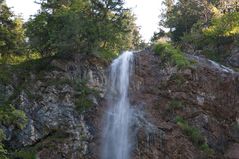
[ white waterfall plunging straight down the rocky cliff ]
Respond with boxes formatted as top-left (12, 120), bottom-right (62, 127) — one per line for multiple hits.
top-left (101, 52), bottom-right (133, 159)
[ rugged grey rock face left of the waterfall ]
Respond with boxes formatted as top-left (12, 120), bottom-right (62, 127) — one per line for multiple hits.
top-left (0, 56), bottom-right (106, 159)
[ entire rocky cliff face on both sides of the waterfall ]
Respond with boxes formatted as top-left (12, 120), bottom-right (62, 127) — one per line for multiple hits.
top-left (0, 50), bottom-right (239, 159)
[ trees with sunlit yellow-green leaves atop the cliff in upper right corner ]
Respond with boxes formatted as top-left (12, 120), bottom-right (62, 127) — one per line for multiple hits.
top-left (155, 0), bottom-right (239, 63)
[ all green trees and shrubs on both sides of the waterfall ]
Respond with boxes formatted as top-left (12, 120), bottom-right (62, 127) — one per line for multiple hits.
top-left (0, 0), bottom-right (239, 159)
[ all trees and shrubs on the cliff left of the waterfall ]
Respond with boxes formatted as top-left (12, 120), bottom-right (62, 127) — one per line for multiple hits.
top-left (0, 0), bottom-right (142, 158)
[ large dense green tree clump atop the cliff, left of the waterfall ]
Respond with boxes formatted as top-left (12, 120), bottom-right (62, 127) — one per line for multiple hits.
top-left (26, 0), bottom-right (140, 60)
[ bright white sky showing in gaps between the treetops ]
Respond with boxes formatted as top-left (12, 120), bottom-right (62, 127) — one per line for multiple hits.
top-left (6, 0), bottom-right (162, 41)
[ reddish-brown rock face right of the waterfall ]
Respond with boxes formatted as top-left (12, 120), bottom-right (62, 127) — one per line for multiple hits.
top-left (131, 51), bottom-right (239, 159)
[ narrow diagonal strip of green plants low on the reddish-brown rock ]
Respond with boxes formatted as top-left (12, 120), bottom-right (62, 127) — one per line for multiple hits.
top-left (176, 116), bottom-right (214, 156)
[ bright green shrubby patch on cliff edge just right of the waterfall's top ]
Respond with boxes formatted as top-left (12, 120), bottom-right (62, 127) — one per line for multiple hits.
top-left (154, 43), bottom-right (190, 69)
